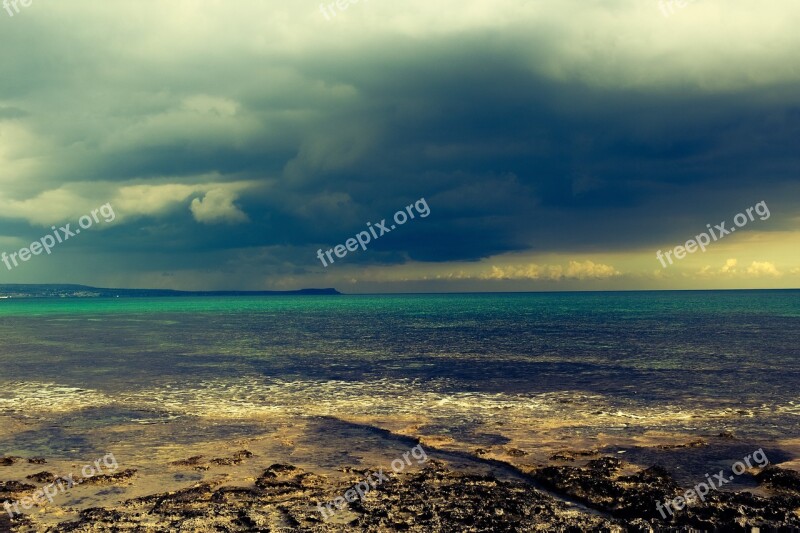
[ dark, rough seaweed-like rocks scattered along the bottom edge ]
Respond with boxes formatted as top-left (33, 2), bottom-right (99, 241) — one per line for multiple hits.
top-left (0, 436), bottom-right (800, 533)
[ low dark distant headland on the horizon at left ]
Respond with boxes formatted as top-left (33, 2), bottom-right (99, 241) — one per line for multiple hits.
top-left (0, 284), bottom-right (341, 299)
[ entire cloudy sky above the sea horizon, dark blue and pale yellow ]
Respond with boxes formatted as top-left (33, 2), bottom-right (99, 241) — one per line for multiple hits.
top-left (0, 0), bottom-right (800, 293)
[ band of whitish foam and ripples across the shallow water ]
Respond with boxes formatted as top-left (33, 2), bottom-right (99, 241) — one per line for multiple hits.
top-left (0, 377), bottom-right (800, 438)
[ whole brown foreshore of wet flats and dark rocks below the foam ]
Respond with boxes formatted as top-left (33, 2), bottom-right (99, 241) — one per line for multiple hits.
top-left (0, 419), bottom-right (800, 531)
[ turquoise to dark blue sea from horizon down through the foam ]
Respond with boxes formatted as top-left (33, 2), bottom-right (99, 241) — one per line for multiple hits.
top-left (0, 291), bottom-right (800, 458)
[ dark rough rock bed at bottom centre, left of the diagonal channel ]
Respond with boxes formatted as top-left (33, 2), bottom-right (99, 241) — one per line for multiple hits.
top-left (40, 461), bottom-right (621, 533)
